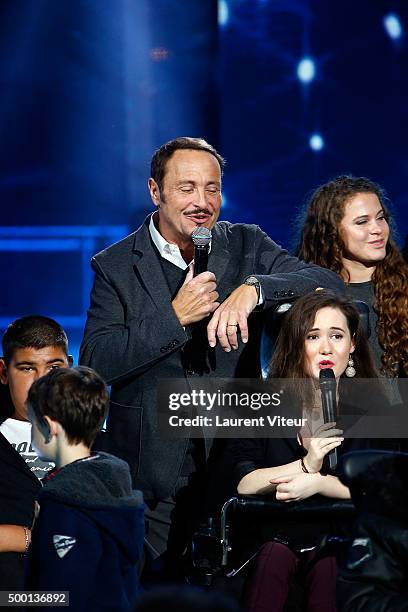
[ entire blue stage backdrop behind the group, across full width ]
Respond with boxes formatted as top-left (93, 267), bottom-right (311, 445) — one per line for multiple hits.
top-left (0, 0), bottom-right (408, 356)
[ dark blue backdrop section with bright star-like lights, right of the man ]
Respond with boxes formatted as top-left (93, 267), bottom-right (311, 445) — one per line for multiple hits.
top-left (218, 0), bottom-right (408, 246)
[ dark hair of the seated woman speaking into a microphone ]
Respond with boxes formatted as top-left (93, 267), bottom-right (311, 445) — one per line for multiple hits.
top-left (269, 290), bottom-right (378, 379)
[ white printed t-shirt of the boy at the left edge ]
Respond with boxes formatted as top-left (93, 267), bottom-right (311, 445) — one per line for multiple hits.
top-left (0, 418), bottom-right (54, 478)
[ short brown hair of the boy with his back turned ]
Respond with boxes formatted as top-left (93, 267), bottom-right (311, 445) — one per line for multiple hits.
top-left (27, 366), bottom-right (109, 447)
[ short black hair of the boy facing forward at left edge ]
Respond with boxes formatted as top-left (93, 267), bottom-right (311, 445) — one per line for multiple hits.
top-left (3, 315), bottom-right (68, 365)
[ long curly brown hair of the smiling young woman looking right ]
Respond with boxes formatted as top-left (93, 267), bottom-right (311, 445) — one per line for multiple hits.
top-left (295, 176), bottom-right (408, 376)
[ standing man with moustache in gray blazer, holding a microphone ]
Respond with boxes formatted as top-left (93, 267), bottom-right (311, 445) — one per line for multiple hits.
top-left (80, 138), bottom-right (342, 568)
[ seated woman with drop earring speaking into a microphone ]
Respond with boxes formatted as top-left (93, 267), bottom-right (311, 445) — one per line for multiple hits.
top-left (230, 291), bottom-right (384, 612)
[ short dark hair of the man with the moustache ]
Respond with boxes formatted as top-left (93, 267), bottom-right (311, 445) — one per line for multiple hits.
top-left (150, 136), bottom-right (225, 191)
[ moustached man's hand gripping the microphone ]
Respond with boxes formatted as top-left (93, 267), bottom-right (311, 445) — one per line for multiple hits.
top-left (171, 268), bottom-right (220, 327)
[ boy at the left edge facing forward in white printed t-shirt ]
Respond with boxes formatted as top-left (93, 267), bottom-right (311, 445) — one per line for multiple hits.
top-left (0, 315), bottom-right (72, 591)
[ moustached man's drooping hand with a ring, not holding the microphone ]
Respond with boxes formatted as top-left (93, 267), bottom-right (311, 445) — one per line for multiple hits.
top-left (207, 285), bottom-right (258, 353)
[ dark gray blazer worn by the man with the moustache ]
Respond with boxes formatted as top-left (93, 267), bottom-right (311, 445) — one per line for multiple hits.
top-left (80, 217), bottom-right (343, 499)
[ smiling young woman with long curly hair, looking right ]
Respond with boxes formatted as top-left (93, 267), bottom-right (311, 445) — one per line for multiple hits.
top-left (295, 176), bottom-right (408, 377)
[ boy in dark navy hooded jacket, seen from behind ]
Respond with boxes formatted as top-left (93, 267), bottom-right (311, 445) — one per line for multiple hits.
top-left (27, 367), bottom-right (144, 612)
